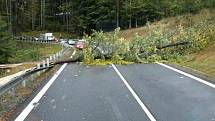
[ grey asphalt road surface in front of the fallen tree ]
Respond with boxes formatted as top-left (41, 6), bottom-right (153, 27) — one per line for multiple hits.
top-left (14, 64), bottom-right (215, 121)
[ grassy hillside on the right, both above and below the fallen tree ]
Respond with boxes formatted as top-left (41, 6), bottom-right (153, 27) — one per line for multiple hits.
top-left (120, 10), bottom-right (215, 78)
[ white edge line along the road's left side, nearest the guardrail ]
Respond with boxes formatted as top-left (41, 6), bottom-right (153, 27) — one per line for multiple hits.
top-left (15, 50), bottom-right (76, 121)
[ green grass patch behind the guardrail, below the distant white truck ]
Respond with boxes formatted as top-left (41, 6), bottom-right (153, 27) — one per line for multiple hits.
top-left (9, 41), bottom-right (62, 63)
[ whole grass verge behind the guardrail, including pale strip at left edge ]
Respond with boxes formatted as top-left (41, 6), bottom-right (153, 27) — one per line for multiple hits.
top-left (0, 41), bottom-right (62, 78)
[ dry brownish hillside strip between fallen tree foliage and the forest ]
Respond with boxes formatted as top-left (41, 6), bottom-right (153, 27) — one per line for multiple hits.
top-left (120, 9), bottom-right (215, 40)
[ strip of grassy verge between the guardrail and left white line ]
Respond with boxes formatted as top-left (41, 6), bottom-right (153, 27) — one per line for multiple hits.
top-left (0, 68), bottom-right (53, 120)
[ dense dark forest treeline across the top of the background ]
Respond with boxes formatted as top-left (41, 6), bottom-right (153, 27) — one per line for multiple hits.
top-left (0, 0), bottom-right (215, 34)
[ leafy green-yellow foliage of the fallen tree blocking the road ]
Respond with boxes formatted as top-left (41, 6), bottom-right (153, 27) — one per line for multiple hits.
top-left (84, 11), bottom-right (215, 64)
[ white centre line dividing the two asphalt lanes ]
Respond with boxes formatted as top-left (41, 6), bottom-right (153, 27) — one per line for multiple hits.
top-left (112, 64), bottom-right (156, 121)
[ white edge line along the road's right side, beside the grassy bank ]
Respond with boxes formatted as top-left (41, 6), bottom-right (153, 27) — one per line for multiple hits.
top-left (156, 62), bottom-right (215, 88)
